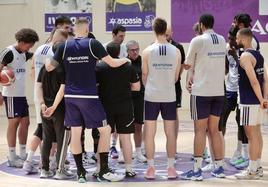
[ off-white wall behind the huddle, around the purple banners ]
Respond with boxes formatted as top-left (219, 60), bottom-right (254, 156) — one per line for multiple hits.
top-left (0, 0), bottom-right (268, 108)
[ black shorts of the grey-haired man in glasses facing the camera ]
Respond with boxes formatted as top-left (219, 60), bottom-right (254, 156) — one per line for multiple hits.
top-left (132, 96), bottom-right (144, 124)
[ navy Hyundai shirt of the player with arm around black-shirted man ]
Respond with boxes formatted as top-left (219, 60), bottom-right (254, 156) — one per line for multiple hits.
top-left (54, 38), bottom-right (108, 98)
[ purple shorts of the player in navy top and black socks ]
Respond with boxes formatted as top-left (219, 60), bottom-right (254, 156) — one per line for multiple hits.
top-left (64, 98), bottom-right (107, 129)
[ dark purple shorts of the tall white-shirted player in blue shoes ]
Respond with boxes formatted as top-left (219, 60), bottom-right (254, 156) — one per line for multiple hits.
top-left (190, 95), bottom-right (224, 120)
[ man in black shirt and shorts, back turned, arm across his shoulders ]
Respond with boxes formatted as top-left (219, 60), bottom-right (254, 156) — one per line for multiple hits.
top-left (96, 42), bottom-right (140, 177)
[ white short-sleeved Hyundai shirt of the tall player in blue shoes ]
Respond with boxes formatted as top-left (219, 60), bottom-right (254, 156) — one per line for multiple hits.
top-left (185, 29), bottom-right (226, 97)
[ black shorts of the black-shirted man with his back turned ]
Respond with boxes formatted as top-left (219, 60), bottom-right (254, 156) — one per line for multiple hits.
top-left (106, 104), bottom-right (135, 134)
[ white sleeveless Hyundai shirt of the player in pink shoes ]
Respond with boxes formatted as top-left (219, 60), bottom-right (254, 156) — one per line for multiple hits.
top-left (144, 43), bottom-right (178, 102)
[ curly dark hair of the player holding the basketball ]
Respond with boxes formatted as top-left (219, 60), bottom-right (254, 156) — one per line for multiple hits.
top-left (15, 28), bottom-right (39, 43)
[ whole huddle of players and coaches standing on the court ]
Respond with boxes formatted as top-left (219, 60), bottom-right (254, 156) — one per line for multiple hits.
top-left (0, 10), bottom-right (268, 183)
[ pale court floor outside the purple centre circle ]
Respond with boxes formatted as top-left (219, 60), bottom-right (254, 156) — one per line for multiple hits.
top-left (0, 106), bottom-right (268, 187)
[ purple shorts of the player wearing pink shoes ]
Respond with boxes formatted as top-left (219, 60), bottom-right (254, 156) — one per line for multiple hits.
top-left (144, 101), bottom-right (177, 121)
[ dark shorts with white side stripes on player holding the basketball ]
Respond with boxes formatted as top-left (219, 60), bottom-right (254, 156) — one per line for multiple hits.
top-left (4, 97), bottom-right (29, 119)
